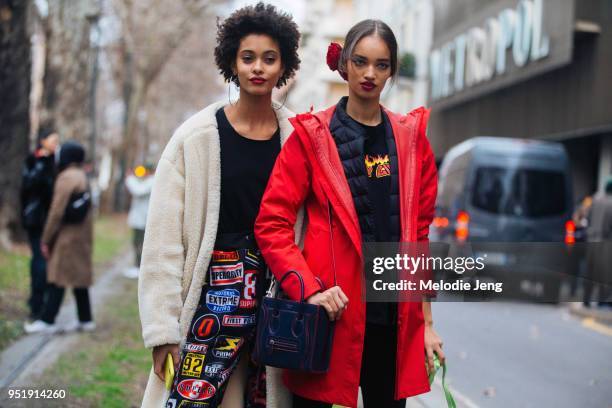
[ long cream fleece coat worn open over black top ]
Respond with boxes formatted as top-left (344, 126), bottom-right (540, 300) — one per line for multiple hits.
top-left (138, 102), bottom-right (302, 408)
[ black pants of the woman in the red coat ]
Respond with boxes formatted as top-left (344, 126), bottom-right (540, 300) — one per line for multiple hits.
top-left (293, 323), bottom-right (406, 408)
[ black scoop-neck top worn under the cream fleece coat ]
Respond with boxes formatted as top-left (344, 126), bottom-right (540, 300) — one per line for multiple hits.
top-left (216, 108), bottom-right (281, 234)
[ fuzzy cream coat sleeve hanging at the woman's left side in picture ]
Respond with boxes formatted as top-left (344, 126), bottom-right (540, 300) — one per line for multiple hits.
top-left (138, 156), bottom-right (185, 348)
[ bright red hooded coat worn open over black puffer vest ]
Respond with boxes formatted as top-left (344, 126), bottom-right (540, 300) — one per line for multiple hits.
top-left (255, 106), bottom-right (437, 407)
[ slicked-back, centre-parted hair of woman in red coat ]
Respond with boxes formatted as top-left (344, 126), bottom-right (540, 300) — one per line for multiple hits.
top-left (338, 19), bottom-right (398, 77)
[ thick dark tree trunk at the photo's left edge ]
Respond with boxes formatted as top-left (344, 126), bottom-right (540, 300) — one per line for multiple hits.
top-left (0, 0), bottom-right (31, 248)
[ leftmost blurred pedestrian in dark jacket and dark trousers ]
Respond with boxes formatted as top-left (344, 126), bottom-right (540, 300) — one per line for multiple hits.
top-left (20, 129), bottom-right (59, 321)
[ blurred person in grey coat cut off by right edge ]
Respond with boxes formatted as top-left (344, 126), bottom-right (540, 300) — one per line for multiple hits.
top-left (583, 177), bottom-right (612, 307)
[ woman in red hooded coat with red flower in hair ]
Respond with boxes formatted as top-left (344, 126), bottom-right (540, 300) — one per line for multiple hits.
top-left (255, 20), bottom-right (444, 408)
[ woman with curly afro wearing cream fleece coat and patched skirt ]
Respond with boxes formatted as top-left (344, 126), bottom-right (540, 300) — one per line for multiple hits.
top-left (138, 3), bottom-right (300, 408)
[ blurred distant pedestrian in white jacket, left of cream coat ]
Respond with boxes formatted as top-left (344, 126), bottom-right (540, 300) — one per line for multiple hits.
top-left (124, 164), bottom-right (154, 278)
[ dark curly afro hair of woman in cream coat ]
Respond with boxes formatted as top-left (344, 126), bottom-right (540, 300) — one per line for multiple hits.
top-left (215, 2), bottom-right (300, 87)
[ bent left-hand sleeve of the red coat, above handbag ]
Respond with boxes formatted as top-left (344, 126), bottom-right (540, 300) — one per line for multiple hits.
top-left (255, 132), bottom-right (321, 300)
